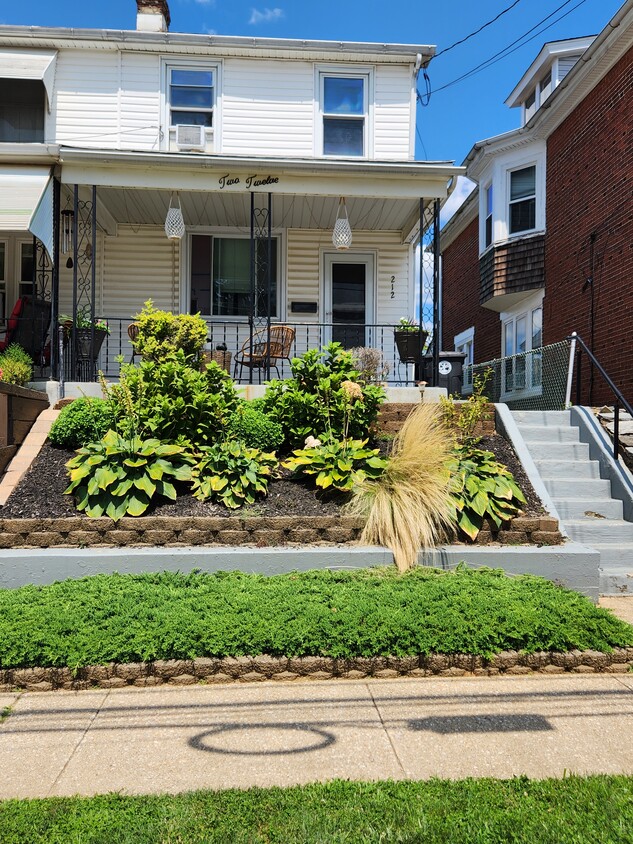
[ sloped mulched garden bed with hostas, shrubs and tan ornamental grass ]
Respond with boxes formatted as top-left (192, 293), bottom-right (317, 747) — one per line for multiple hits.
top-left (0, 303), bottom-right (558, 571)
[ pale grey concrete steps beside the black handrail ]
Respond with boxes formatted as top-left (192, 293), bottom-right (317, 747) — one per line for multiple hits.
top-left (512, 410), bottom-right (633, 598)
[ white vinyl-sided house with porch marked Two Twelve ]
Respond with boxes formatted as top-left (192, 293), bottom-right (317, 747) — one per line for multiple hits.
top-left (0, 0), bottom-right (463, 390)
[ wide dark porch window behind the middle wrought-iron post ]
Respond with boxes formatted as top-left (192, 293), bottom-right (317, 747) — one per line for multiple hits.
top-left (190, 234), bottom-right (278, 318)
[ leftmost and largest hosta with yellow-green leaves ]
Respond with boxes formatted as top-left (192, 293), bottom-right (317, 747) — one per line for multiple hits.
top-left (64, 431), bottom-right (194, 521)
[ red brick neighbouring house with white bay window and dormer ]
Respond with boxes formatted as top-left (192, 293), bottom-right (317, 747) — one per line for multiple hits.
top-left (441, 0), bottom-right (633, 403)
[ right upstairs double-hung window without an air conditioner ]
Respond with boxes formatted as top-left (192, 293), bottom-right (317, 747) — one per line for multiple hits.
top-left (320, 73), bottom-right (369, 157)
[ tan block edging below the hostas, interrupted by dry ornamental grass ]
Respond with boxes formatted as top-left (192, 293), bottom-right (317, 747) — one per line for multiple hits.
top-left (0, 515), bottom-right (562, 549)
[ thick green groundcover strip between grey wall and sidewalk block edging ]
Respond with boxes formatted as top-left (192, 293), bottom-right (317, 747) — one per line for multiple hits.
top-left (0, 568), bottom-right (633, 668)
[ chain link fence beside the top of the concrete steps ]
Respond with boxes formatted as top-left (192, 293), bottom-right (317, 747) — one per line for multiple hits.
top-left (462, 340), bottom-right (570, 410)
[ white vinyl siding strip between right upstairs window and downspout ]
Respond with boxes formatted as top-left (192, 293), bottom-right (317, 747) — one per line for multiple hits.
top-left (374, 65), bottom-right (413, 160)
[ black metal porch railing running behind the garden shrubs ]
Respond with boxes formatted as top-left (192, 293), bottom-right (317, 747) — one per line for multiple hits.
top-left (64, 317), bottom-right (422, 386)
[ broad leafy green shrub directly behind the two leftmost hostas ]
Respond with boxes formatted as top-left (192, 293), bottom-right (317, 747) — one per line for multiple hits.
top-left (108, 351), bottom-right (238, 446)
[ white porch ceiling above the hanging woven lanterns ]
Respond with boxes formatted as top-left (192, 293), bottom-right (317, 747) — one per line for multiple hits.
top-left (97, 187), bottom-right (428, 237)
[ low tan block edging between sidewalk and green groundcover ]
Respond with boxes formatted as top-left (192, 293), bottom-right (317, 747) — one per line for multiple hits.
top-left (0, 648), bottom-right (633, 692)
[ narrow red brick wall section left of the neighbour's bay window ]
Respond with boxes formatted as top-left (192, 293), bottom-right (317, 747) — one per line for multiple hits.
top-left (442, 219), bottom-right (501, 363)
